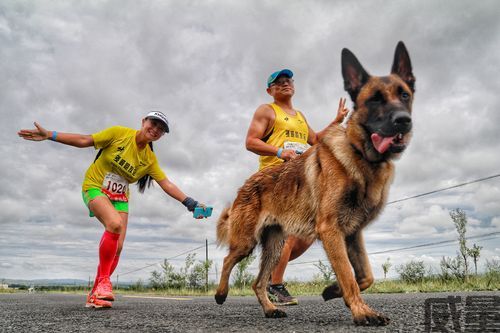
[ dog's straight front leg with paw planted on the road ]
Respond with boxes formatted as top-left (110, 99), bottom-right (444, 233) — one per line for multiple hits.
top-left (318, 222), bottom-right (389, 326)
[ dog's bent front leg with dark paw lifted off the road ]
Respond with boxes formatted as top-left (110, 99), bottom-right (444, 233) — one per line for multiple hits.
top-left (321, 230), bottom-right (373, 301)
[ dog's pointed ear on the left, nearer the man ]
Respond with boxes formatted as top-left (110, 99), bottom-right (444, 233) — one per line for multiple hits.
top-left (342, 49), bottom-right (370, 102)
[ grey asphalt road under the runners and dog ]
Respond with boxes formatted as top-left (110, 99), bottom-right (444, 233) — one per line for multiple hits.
top-left (0, 292), bottom-right (500, 332)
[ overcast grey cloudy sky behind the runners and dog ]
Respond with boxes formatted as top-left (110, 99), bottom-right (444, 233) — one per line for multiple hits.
top-left (0, 0), bottom-right (500, 281)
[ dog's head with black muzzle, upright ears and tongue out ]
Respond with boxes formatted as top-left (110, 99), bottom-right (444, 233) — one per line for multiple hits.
top-left (342, 42), bottom-right (415, 162)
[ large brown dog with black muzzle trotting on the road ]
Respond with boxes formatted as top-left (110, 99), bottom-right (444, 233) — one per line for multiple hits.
top-left (215, 42), bottom-right (415, 326)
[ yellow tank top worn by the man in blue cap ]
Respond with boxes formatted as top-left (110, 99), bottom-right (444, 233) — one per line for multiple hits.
top-left (259, 103), bottom-right (309, 170)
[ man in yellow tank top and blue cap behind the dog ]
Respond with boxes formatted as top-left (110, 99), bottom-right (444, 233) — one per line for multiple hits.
top-left (246, 69), bottom-right (348, 305)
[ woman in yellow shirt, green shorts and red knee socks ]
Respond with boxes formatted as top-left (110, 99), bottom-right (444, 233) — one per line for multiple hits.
top-left (18, 111), bottom-right (204, 308)
